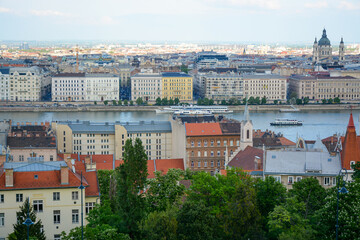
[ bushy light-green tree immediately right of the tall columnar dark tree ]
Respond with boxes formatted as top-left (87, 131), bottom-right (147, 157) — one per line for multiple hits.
top-left (146, 169), bottom-right (185, 211)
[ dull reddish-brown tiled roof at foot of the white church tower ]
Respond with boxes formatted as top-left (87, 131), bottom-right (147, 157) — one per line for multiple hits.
top-left (228, 146), bottom-right (263, 170)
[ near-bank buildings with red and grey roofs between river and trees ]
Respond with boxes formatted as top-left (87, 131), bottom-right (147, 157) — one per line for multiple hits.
top-left (0, 111), bottom-right (360, 239)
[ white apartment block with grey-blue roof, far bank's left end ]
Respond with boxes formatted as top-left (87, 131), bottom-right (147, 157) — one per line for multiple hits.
top-left (9, 67), bottom-right (50, 101)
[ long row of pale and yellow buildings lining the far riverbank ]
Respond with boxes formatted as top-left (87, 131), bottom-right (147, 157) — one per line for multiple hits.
top-left (0, 67), bottom-right (360, 103)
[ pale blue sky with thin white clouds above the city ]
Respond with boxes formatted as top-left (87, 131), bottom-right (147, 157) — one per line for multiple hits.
top-left (0, 0), bottom-right (360, 45)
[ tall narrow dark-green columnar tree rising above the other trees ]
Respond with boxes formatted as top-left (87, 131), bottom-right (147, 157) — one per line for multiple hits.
top-left (116, 138), bottom-right (148, 238)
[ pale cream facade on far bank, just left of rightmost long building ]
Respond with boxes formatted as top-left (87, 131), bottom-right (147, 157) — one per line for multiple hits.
top-left (243, 74), bottom-right (287, 101)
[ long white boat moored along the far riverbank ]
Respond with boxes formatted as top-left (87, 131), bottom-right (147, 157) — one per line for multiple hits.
top-left (155, 105), bottom-right (233, 114)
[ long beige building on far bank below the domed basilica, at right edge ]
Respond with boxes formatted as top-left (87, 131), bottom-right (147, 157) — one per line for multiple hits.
top-left (289, 75), bottom-right (360, 101)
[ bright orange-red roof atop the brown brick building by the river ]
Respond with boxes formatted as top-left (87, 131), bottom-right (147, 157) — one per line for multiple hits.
top-left (185, 123), bottom-right (222, 136)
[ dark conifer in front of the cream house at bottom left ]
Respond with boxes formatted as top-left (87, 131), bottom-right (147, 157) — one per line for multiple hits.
top-left (9, 198), bottom-right (46, 240)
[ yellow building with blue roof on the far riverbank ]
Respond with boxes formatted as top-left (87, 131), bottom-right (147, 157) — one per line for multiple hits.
top-left (161, 72), bottom-right (193, 102)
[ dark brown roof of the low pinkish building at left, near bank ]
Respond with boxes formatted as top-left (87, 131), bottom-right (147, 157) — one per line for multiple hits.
top-left (7, 137), bottom-right (56, 148)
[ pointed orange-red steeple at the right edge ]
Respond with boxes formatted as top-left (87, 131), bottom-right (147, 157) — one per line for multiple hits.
top-left (341, 113), bottom-right (360, 170)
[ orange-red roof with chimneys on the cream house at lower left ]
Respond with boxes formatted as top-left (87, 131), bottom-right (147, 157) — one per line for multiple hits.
top-left (0, 169), bottom-right (88, 189)
